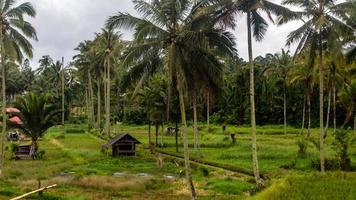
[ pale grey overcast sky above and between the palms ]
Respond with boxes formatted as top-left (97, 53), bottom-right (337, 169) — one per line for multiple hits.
top-left (21, 0), bottom-right (298, 67)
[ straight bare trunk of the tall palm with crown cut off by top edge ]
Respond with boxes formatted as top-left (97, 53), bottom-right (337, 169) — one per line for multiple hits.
top-left (247, 11), bottom-right (261, 187)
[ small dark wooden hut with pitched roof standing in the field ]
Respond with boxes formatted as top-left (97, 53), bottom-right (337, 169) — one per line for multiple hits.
top-left (102, 133), bottom-right (141, 157)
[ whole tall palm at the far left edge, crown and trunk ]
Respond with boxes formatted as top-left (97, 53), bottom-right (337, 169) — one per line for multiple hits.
top-left (0, 0), bottom-right (37, 176)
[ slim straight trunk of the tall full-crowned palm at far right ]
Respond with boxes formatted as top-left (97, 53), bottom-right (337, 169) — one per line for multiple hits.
top-left (319, 32), bottom-right (325, 172)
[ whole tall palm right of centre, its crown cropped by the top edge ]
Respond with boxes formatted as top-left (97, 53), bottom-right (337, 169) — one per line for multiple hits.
top-left (225, 0), bottom-right (296, 186)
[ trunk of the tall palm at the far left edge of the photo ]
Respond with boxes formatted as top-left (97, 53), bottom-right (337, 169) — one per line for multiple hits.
top-left (0, 34), bottom-right (7, 176)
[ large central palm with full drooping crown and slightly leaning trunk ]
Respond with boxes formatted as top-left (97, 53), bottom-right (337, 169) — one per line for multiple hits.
top-left (107, 0), bottom-right (236, 199)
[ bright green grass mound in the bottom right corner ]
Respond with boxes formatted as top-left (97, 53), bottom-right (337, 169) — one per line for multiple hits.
top-left (253, 172), bottom-right (356, 200)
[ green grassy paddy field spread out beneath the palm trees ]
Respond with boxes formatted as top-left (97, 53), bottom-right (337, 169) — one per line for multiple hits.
top-left (0, 124), bottom-right (356, 200)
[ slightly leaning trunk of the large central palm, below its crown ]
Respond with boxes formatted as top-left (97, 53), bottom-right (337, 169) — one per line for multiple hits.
top-left (179, 87), bottom-right (197, 200)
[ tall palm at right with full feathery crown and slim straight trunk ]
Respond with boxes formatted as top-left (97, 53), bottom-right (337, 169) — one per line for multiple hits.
top-left (279, 0), bottom-right (356, 172)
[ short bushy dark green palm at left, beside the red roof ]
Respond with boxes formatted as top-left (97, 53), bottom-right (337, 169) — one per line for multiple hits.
top-left (10, 93), bottom-right (62, 158)
